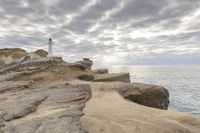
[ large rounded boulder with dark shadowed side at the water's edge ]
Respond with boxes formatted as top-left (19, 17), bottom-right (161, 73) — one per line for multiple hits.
top-left (119, 83), bottom-right (169, 110)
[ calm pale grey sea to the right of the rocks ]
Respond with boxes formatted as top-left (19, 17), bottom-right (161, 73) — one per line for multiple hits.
top-left (105, 65), bottom-right (200, 117)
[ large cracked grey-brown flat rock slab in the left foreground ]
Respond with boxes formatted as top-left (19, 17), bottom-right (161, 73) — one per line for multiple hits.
top-left (0, 85), bottom-right (90, 133)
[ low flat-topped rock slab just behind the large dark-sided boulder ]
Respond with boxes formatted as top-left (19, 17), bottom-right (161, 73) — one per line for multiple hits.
top-left (94, 73), bottom-right (130, 82)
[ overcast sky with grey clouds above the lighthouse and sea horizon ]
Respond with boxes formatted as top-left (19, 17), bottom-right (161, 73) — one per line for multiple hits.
top-left (0, 0), bottom-right (200, 65)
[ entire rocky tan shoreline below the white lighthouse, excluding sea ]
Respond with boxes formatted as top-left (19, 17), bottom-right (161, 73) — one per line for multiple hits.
top-left (0, 49), bottom-right (200, 133)
